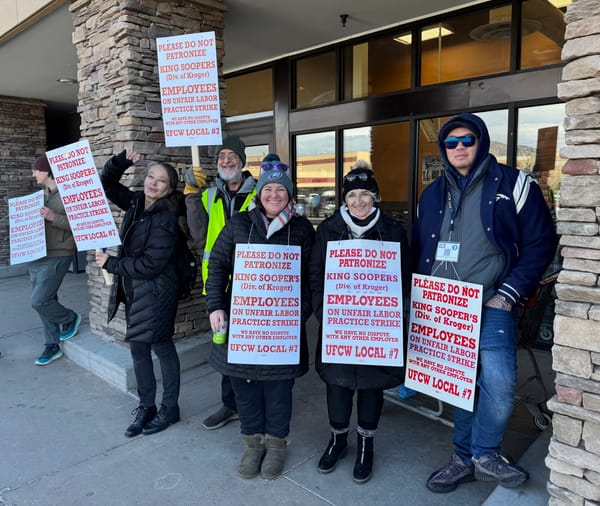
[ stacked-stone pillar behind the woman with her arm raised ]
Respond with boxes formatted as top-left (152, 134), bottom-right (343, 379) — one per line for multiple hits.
top-left (70, 0), bottom-right (225, 338)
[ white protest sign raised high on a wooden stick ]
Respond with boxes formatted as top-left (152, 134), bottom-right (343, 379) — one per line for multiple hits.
top-left (156, 32), bottom-right (222, 147)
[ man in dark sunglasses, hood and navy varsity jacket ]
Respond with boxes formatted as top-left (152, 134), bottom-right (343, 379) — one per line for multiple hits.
top-left (412, 114), bottom-right (557, 493)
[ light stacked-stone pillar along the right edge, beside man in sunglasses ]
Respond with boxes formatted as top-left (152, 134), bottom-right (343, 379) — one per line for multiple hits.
top-left (546, 0), bottom-right (600, 505)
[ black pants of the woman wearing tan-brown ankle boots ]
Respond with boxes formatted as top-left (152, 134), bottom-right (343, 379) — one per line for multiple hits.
top-left (231, 376), bottom-right (295, 438)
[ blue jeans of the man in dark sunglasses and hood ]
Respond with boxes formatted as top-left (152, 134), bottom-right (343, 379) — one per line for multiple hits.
top-left (454, 307), bottom-right (518, 463)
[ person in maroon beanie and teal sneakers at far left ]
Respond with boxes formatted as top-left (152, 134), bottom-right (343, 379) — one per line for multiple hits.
top-left (28, 155), bottom-right (81, 365)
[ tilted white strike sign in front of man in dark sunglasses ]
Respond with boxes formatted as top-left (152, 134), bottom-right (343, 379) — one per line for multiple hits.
top-left (405, 274), bottom-right (483, 411)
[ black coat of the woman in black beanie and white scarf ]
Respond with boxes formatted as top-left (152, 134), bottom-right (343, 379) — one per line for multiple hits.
top-left (310, 210), bottom-right (411, 390)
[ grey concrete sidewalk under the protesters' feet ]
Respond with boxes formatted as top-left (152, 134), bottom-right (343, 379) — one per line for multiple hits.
top-left (0, 273), bottom-right (550, 506)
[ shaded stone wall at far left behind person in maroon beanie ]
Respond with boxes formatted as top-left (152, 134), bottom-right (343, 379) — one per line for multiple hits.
top-left (0, 97), bottom-right (46, 275)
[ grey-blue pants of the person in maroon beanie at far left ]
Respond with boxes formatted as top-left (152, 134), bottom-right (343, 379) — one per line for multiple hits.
top-left (27, 256), bottom-right (75, 344)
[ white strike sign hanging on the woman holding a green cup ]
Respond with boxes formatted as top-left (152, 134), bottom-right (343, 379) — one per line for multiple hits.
top-left (227, 244), bottom-right (301, 365)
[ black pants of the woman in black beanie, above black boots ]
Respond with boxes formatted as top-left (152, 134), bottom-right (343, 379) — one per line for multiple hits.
top-left (327, 383), bottom-right (383, 430)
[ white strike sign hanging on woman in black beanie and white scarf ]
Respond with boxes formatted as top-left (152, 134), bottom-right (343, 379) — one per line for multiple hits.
top-left (321, 239), bottom-right (403, 367)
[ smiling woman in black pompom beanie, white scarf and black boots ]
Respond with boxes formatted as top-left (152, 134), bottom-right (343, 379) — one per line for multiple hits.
top-left (310, 160), bottom-right (411, 483)
